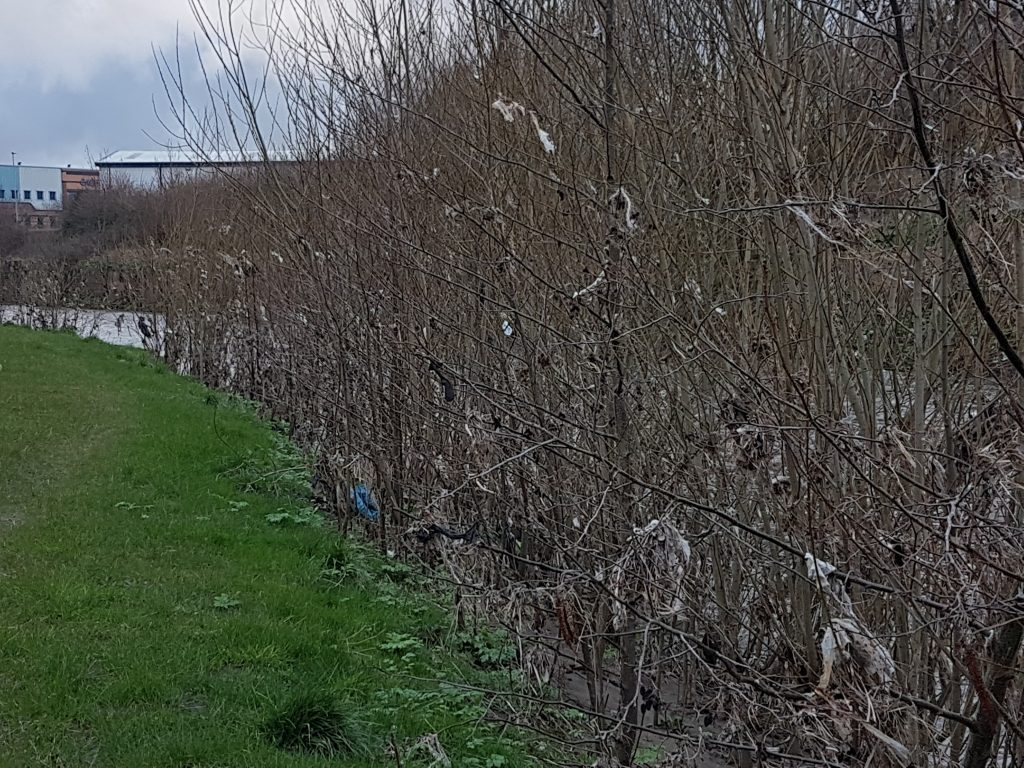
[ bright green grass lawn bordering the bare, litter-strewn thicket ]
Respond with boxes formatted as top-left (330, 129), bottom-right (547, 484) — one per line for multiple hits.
top-left (0, 327), bottom-right (532, 768)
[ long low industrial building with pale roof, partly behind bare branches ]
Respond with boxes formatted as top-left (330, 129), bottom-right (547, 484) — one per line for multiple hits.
top-left (96, 150), bottom-right (289, 189)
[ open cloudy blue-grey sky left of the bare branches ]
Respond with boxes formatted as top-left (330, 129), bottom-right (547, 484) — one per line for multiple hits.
top-left (0, 0), bottom-right (211, 166)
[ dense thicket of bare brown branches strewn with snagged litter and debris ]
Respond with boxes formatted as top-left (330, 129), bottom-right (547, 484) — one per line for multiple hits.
top-left (94, 0), bottom-right (1024, 767)
